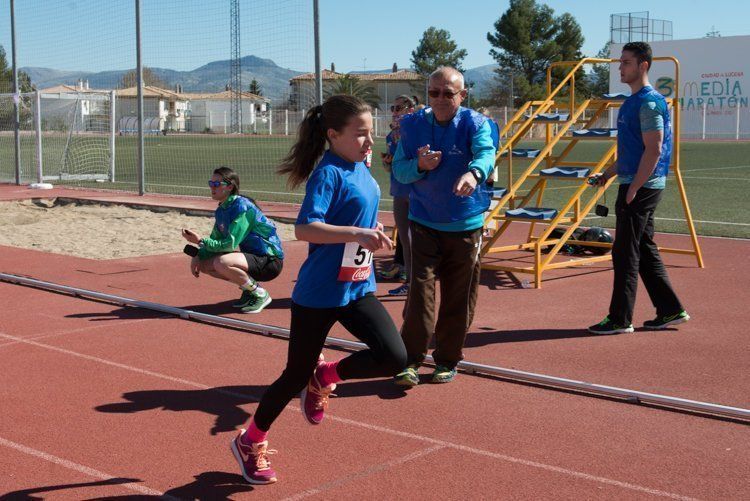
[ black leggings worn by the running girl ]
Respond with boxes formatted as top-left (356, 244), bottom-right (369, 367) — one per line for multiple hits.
top-left (253, 294), bottom-right (406, 431)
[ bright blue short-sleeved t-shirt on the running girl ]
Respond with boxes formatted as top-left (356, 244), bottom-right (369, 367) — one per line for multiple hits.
top-left (292, 151), bottom-right (380, 308)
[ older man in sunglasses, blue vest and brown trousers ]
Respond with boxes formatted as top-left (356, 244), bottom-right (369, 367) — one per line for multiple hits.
top-left (393, 67), bottom-right (496, 386)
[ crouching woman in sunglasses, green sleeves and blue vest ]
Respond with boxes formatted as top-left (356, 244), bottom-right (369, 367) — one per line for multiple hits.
top-left (182, 167), bottom-right (284, 313)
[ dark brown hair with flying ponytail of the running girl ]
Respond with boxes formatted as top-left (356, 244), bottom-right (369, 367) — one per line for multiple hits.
top-left (278, 95), bottom-right (371, 188)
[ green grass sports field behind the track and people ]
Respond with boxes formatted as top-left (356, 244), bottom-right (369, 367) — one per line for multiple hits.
top-left (0, 135), bottom-right (750, 238)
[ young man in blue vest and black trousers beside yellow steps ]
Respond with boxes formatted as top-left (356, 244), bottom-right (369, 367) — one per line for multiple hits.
top-left (588, 42), bottom-right (690, 334)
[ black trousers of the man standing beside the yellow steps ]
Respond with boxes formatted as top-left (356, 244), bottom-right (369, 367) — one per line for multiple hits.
top-left (609, 184), bottom-right (682, 325)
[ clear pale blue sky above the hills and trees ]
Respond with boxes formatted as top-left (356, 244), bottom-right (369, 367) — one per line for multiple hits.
top-left (0, 0), bottom-right (750, 71)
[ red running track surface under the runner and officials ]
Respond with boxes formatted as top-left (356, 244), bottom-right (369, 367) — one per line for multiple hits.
top-left (0, 186), bottom-right (750, 499)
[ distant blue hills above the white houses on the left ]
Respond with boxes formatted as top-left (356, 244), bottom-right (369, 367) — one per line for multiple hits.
top-left (21, 56), bottom-right (301, 100)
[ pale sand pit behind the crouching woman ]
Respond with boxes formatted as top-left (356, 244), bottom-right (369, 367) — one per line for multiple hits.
top-left (0, 199), bottom-right (294, 259)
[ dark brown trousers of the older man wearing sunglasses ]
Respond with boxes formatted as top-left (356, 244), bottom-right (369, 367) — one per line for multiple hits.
top-left (401, 221), bottom-right (482, 368)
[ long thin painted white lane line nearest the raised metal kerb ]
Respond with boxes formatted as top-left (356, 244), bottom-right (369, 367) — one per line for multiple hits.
top-left (0, 332), bottom-right (695, 501)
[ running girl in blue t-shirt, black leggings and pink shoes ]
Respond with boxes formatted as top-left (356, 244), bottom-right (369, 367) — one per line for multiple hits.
top-left (231, 95), bottom-right (406, 484)
